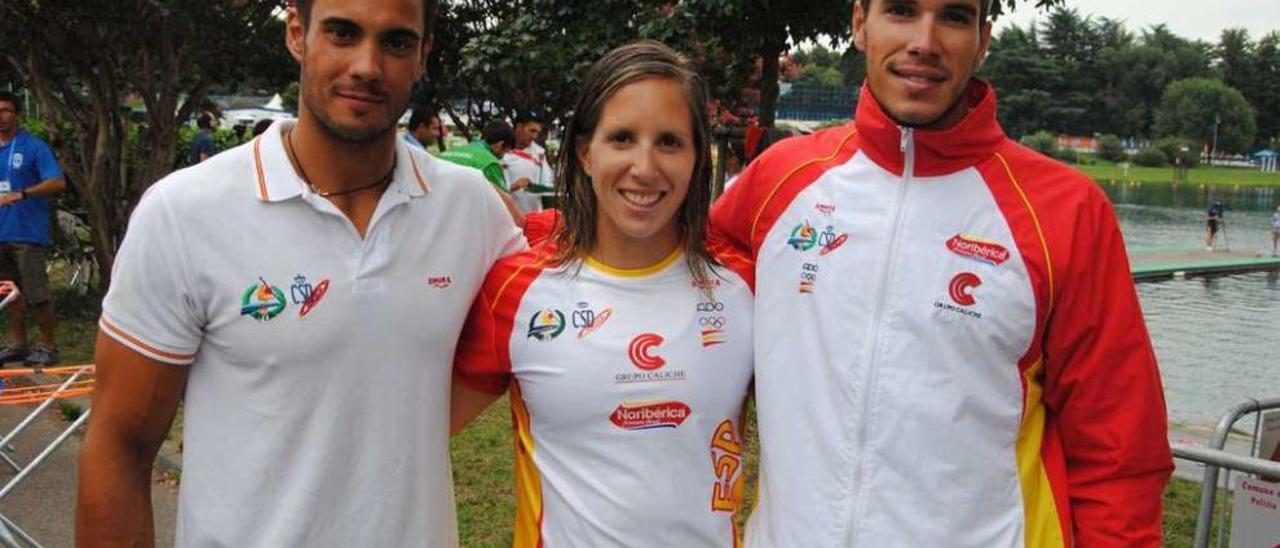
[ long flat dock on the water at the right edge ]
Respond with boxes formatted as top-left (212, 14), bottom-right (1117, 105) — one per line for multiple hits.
top-left (1129, 247), bottom-right (1280, 282)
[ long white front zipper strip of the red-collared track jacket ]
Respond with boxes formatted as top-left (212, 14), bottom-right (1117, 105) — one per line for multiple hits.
top-left (846, 127), bottom-right (915, 545)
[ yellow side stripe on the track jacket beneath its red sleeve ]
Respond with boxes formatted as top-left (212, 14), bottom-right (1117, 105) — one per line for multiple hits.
top-left (1016, 360), bottom-right (1066, 547)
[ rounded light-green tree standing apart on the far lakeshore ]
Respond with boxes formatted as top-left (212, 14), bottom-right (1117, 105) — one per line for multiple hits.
top-left (1156, 78), bottom-right (1257, 152)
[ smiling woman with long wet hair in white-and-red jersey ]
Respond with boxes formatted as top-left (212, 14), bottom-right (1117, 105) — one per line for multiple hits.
top-left (452, 41), bottom-right (751, 548)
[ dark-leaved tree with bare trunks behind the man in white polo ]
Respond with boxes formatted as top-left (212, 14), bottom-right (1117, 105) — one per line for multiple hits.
top-left (0, 0), bottom-right (292, 282)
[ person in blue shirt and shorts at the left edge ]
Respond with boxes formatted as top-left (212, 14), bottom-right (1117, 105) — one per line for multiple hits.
top-left (0, 91), bottom-right (67, 366)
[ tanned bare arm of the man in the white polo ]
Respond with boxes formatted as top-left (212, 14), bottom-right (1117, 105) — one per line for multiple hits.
top-left (76, 333), bottom-right (187, 547)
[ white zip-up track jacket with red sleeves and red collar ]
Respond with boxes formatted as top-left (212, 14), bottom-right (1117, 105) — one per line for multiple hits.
top-left (712, 81), bottom-right (1172, 547)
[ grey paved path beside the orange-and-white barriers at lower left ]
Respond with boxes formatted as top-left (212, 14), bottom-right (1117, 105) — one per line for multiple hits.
top-left (0, 394), bottom-right (178, 548)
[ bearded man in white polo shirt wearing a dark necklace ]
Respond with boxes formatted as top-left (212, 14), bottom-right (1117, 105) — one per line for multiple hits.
top-left (77, 0), bottom-right (522, 547)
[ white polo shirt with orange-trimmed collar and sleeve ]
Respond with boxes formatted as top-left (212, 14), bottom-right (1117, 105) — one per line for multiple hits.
top-left (100, 123), bottom-right (524, 547)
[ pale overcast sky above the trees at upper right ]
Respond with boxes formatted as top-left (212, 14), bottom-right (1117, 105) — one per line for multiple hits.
top-left (996, 0), bottom-right (1280, 44)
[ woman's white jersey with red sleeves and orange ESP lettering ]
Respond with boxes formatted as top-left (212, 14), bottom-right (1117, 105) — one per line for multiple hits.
top-left (456, 248), bottom-right (753, 548)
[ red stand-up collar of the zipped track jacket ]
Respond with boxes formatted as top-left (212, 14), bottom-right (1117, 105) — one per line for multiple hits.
top-left (854, 78), bottom-right (1005, 177)
